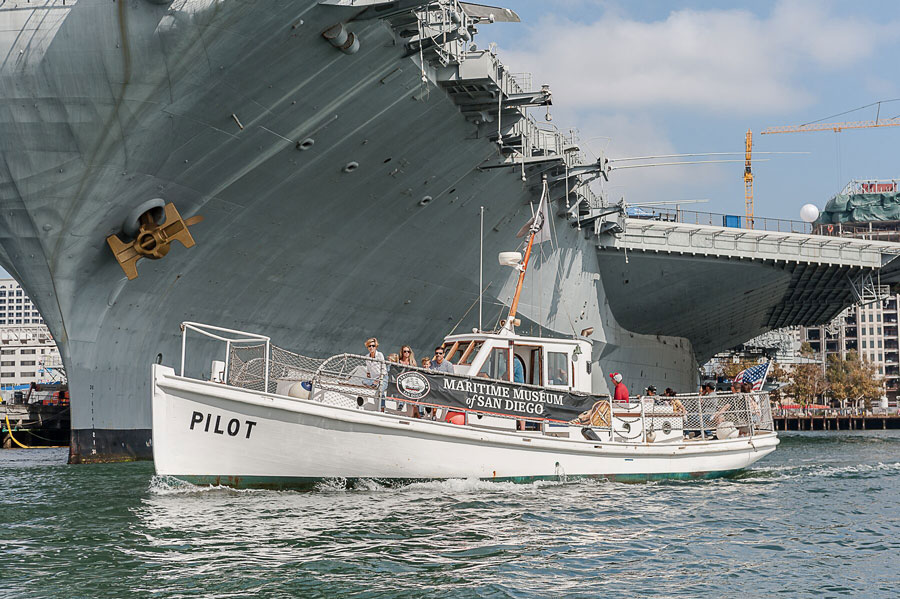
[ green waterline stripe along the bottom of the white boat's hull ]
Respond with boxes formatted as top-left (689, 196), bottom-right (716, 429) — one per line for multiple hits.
top-left (173, 469), bottom-right (742, 490)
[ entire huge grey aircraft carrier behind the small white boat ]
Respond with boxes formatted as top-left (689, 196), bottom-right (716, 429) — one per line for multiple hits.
top-left (0, 0), bottom-right (897, 462)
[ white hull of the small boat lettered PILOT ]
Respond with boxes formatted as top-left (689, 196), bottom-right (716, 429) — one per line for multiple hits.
top-left (153, 365), bottom-right (778, 487)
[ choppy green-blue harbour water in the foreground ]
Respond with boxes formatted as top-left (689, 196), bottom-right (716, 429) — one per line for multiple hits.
top-left (0, 431), bottom-right (900, 598)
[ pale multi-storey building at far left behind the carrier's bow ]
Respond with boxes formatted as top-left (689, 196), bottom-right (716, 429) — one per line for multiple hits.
top-left (0, 279), bottom-right (62, 390)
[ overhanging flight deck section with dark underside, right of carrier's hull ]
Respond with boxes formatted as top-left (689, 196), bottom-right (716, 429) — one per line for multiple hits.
top-left (592, 214), bottom-right (900, 361)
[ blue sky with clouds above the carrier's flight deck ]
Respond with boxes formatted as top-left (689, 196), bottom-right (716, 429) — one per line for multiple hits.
top-left (476, 0), bottom-right (900, 219)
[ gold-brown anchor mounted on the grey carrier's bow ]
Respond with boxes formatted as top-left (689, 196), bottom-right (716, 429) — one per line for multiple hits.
top-left (106, 203), bottom-right (203, 280)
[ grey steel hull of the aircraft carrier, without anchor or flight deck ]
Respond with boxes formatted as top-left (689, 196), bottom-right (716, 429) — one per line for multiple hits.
top-left (0, 0), bottom-right (788, 461)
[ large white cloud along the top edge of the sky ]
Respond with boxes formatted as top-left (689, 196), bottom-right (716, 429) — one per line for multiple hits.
top-left (502, 0), bottom-right (898, 115)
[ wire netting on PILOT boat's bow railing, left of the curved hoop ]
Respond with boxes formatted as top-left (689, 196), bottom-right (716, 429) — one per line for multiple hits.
top-left (228, 343), bottom-right (325, 392)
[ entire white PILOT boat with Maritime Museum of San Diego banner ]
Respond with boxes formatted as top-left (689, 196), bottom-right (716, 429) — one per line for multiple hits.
top-left (153, 183), bottom-right (778, 488)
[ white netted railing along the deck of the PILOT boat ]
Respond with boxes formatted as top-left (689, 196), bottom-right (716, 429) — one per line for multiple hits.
top-left (180, 322), bottom-right (774, 443)
